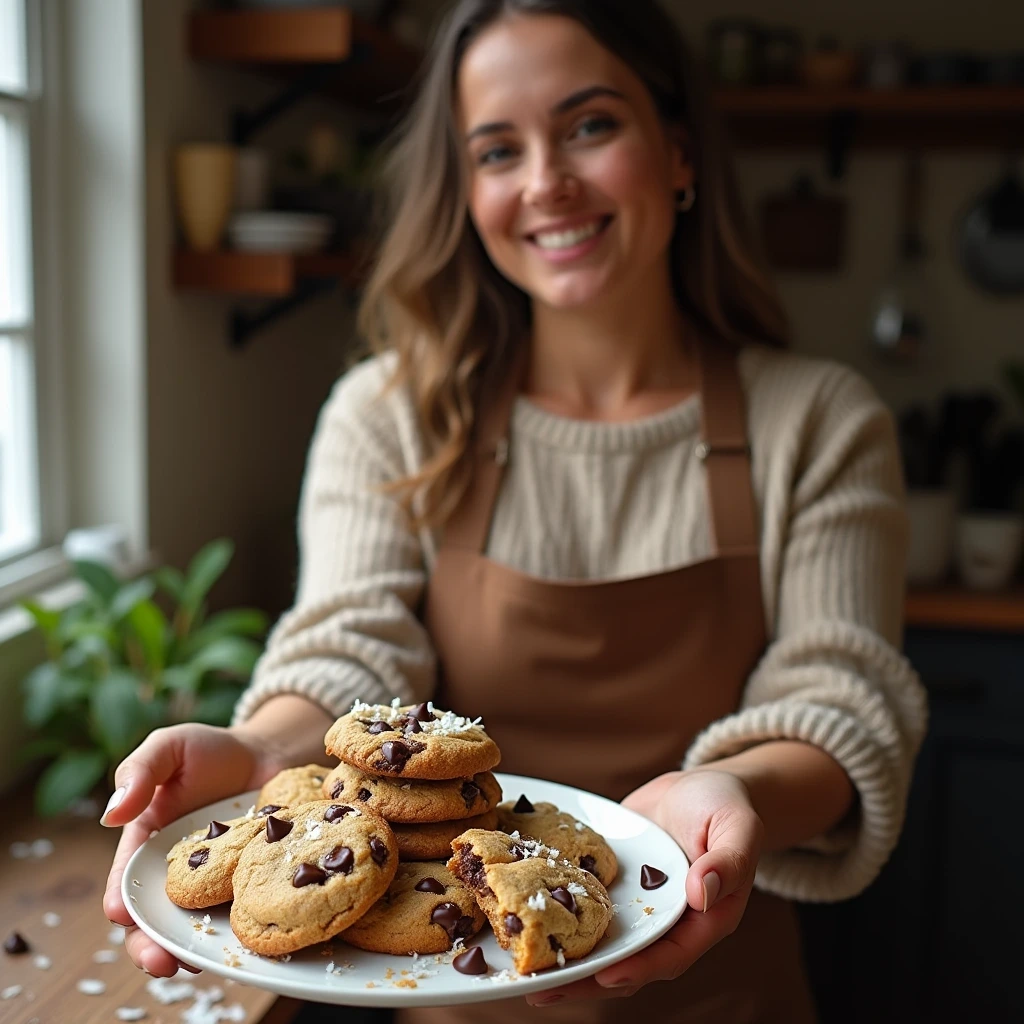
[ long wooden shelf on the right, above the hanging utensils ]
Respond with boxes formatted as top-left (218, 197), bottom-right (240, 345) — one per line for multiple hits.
top-left (713, 85), bottom-right (1024, 150)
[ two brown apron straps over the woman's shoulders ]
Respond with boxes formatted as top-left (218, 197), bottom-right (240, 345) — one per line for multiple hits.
top-left (442, 339), bottom-right (758, 555)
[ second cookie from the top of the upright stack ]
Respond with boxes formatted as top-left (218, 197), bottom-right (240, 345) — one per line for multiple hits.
top-left (324, 761), bottom-right (502, 823)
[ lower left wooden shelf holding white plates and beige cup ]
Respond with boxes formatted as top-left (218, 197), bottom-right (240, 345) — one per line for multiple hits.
top-left (173, 249), bottom-right (359, 298)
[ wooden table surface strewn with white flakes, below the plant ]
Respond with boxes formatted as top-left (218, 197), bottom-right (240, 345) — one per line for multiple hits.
top-left (0, 792), bottom-right (300, 1024)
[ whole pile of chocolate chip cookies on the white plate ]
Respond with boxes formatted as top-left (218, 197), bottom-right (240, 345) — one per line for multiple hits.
top-left (167, 700), bottom-right (617, 973)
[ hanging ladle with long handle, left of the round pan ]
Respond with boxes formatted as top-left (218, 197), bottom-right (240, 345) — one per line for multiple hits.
top-left (870, 153), bottom-right (930, 362)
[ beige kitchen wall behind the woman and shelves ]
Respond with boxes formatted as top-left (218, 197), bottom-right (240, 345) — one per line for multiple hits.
top-left (143, 0), bottom-right (1024, 610)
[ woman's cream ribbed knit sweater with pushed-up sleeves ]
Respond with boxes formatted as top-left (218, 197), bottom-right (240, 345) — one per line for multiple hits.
top-left (234, 347), bottom-right (927, 900)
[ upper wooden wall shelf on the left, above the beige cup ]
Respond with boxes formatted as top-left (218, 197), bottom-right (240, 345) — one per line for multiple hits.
top-left (187, 7), bottom-right (419, 106)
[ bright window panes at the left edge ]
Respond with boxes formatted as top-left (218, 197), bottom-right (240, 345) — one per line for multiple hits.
top-left (0, 0), bottom-right (41, 563)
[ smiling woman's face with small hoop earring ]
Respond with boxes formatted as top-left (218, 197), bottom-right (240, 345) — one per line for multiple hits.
top-left (458, 15), bottom-right (693, 309)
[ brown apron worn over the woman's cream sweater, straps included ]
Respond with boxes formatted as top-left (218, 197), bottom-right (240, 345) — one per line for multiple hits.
top-left (407, 343), bottom-right (815, 1024)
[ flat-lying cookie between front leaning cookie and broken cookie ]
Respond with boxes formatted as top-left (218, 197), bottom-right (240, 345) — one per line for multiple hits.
top-left (338, 862), bottom-right (486, 955)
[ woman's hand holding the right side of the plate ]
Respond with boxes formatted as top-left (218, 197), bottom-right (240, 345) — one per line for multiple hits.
top-left (527, 768), bottom-right (764, 1006)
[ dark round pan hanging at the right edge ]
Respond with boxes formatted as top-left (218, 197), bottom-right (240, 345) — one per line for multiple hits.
top-left (956, 154), bottom-right (1024, 295)
